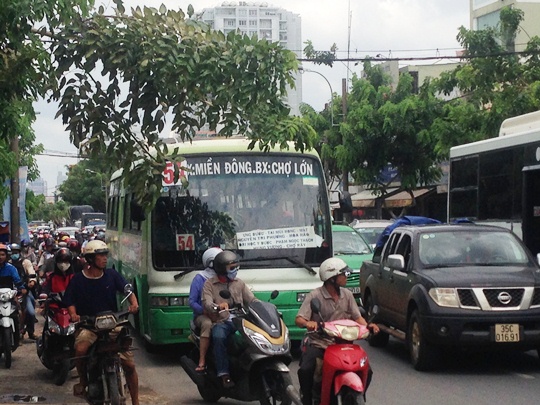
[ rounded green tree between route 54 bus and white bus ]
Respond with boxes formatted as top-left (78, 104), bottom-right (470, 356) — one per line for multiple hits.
top-left (303, 61), bottom-right (443, 216)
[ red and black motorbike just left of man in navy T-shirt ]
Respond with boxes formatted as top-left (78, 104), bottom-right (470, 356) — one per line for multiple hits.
top-left (36, 293), bottom-right (76, 385)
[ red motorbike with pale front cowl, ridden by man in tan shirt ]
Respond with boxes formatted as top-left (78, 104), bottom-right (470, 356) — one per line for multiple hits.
top-left (309, 298), bottom-right (370, 405)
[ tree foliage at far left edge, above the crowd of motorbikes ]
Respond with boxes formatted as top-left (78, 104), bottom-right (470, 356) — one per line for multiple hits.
top-left (0, 0), bottom-right (88, 201)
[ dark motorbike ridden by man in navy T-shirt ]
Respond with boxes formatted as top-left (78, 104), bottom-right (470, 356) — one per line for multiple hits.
top-left (77, 284), bottom-right (133, 405)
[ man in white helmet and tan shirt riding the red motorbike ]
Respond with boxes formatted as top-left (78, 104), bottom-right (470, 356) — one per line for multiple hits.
top-left (295, 257), bottom-right (379, 405)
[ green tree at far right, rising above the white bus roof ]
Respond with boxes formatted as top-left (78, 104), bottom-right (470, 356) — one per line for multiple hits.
top-left (433, 7), bottom-right (540, 155)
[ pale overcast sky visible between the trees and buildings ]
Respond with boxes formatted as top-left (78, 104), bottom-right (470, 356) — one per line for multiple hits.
top-left (33, 0), bottom-right (470, 195)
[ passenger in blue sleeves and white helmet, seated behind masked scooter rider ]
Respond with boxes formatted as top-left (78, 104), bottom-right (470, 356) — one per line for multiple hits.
top-left (189, 247), bottom-right (223, 373)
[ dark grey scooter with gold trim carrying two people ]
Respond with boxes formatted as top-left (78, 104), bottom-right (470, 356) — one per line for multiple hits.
top-left (180, 291), bottom-right (302, 405)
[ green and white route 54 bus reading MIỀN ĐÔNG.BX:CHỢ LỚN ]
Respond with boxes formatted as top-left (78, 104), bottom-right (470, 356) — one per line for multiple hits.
top-left (107, 138), bottom-right (332, 348)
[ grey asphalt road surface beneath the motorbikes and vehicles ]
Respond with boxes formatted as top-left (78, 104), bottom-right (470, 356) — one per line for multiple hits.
top-left (0, 318), bottom-right (540, 405)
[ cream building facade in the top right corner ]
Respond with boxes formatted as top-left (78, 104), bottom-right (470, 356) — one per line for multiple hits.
top-left (470, 0), bottom-right (540, 52)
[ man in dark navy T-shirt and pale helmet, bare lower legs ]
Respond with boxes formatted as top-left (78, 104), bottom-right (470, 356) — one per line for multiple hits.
top-left (63, 240), bottom-right (139, 405)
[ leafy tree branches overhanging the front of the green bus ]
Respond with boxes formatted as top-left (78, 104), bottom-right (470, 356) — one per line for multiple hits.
top-left (0, 0), bottom-right (316, 213)
